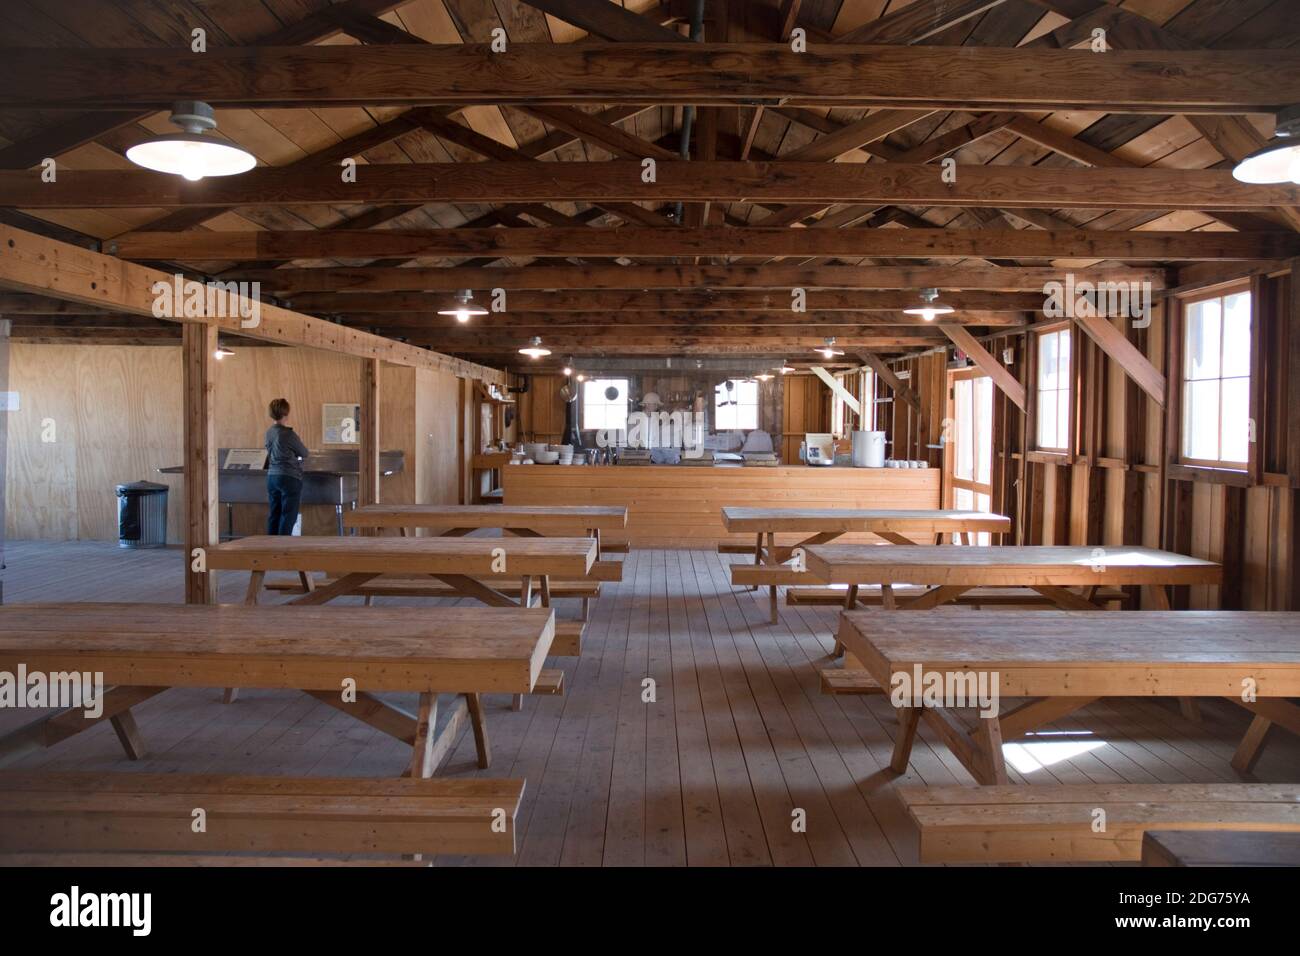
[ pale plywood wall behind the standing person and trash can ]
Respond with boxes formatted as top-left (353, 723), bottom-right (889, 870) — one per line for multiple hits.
top-left (5, 342), bottom-right (470, 542)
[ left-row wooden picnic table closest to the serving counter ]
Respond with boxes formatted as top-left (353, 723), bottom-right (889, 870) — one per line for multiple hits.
top-left (343, 505), bottom-right (628, 559)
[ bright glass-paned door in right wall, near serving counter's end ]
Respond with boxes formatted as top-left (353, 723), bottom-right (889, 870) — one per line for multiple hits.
top-left (944, 368), bottom-right (993, 545)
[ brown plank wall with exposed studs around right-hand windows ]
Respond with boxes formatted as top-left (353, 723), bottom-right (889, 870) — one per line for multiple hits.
top-left (876, 274), bottom-right (1300, 610)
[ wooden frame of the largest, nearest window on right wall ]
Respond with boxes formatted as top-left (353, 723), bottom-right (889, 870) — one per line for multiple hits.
top-left (1170, 281), bottom-right (1260, 476)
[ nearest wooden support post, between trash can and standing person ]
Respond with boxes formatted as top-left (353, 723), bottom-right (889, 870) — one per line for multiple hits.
top-left (181, 323), bottom-right (217, 604)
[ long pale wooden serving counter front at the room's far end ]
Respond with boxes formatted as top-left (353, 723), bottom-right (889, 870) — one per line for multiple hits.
top-left (502, 464), bottom-right (940, 549)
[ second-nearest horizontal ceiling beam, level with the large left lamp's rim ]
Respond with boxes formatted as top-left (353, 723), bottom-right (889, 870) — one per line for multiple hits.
top-left (15, 160), bottom-right (1300, 211)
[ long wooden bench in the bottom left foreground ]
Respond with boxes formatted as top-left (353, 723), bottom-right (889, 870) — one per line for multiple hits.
top-left (0, 771), bottom-right (524, 855)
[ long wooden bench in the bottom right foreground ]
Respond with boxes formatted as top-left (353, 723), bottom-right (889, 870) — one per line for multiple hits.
top-left (898, 783), bottom-right (1300, 864)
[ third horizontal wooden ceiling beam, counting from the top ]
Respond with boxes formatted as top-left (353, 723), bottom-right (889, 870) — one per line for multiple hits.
top-left (108, 227), bottom-right (1300, 261)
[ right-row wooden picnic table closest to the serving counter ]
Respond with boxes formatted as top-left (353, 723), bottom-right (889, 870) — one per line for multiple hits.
top-left (723, 505), bottom-right (1011, 624)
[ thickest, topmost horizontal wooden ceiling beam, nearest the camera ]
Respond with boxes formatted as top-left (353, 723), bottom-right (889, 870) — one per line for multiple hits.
top-left (0, 43), bottom-right (1300, 113)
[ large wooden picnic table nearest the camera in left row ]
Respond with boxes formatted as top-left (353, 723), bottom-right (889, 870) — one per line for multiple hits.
top-left (0, 604), bottom-right (555, 777)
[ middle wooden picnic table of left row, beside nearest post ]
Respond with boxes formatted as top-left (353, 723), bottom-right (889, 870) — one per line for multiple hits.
top-left (207, 535), bottom-right (595, 607)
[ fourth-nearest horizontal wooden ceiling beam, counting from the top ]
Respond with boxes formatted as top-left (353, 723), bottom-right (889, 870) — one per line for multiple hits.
top-left (228, 264), bottom-right (1165, 293)
